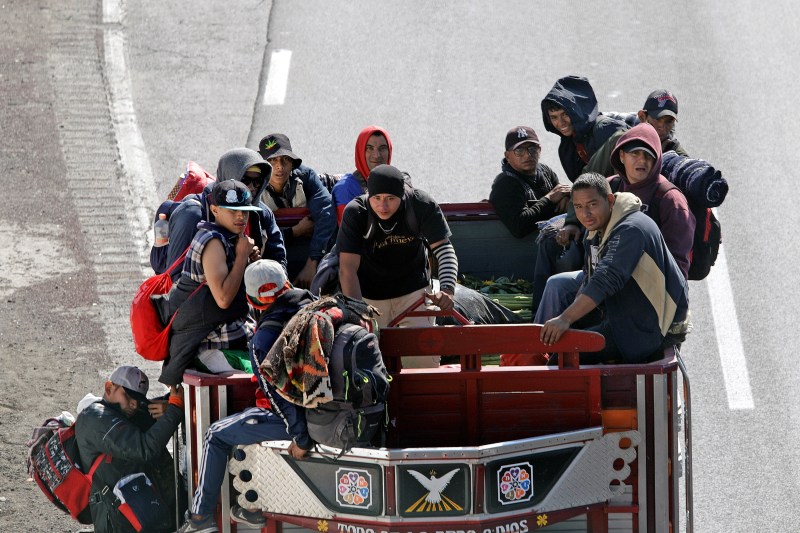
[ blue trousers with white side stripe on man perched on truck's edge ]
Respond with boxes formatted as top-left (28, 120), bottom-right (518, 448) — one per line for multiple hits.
top-left (191, 407), bottom-right (292, 516)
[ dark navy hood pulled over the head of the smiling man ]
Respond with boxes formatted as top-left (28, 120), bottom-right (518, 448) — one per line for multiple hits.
top-left (542, 76), bottom-right (600, 139)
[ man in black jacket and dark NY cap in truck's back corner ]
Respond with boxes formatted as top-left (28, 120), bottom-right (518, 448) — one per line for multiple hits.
top-left (489, 126), bottom-right (570, 239)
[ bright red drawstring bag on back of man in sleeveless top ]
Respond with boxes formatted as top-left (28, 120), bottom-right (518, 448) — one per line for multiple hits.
top-left (131, 248), bottom-right (205, 361)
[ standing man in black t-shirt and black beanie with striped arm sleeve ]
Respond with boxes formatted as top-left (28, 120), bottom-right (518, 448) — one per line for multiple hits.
top-left (336, 165), bottom-right (458, 368)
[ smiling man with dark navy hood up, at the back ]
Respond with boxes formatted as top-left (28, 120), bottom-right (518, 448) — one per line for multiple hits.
top-left (542, 76), bottom-right (628, 182)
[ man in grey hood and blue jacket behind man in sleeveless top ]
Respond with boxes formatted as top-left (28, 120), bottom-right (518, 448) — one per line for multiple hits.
top-left (153, 148), bottom-right (286, 282)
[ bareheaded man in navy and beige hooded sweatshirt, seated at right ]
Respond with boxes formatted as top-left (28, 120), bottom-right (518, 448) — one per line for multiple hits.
top-left (540, 173), bottom-right (689, 364)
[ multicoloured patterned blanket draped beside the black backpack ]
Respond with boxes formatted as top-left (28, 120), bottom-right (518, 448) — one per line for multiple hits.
top-left (259, 294), bottom-right (376, 408)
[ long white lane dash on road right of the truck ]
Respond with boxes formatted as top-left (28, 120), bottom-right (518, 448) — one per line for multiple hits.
top-left (706, 210), bottom-right (755, 410)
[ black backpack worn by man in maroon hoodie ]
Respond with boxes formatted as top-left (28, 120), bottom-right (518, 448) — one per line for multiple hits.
top-left (610, 177), bottom-right (722, 280)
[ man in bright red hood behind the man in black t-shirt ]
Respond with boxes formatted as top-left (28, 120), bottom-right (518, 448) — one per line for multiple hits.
top-left (331, 126), bottom-right (392, 224)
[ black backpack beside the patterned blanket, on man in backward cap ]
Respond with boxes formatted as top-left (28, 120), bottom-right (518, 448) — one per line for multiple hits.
top-left (306, 323), bottom-right (391, 454)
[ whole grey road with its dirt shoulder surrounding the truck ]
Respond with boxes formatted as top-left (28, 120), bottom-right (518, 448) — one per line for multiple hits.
top-left (0, 0), bottom-right (800, 532)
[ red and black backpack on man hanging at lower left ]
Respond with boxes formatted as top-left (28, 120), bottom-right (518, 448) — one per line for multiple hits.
top-left (27, 418), bottom-right (111, 524)
